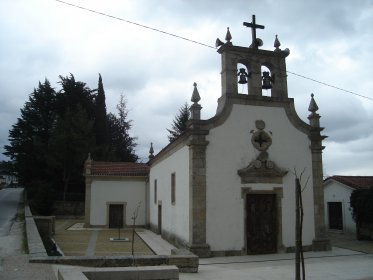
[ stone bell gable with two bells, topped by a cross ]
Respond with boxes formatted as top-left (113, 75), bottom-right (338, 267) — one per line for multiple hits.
top-left (216, 15), bottom-right (290, 113)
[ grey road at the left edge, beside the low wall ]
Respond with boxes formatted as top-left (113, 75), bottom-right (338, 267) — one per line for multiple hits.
top-left (0, 188), bottom-right (23, 237)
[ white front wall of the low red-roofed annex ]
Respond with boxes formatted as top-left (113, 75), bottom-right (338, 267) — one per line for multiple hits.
top-left (90, 178), bottom-right (146, 227)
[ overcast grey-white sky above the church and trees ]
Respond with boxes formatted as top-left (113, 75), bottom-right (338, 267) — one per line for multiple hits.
top-left (0, 0), bottom-right (373, 175)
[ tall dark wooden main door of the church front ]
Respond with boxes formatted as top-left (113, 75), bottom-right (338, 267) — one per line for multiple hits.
top-left (246, 194), bottom-right (277, 254)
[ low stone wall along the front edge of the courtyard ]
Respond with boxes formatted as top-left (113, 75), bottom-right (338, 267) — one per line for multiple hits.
top-left (30, 255), bottom-right (198, 273)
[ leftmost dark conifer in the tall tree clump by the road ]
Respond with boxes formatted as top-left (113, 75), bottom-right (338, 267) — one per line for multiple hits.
top-left (4, 79), bottom-right (56, 187)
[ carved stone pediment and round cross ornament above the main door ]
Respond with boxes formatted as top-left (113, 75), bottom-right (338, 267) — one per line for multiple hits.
top-left (237, 120), bottom-right (287, 184)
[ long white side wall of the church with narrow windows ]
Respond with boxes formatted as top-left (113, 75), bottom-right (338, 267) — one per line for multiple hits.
top-left (149, 146), bottom-right (189, 242)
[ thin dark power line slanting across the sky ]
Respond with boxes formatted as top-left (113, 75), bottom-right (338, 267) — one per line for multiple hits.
top-left (55, 0), bottom-right (373, 101)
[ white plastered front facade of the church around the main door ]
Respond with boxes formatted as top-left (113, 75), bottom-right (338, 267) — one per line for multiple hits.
top-left (207, 105), bottom-right (314, 251)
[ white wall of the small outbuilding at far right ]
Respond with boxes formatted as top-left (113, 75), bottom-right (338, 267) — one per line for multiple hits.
top-left (324, 180), bottom-right (356, 234)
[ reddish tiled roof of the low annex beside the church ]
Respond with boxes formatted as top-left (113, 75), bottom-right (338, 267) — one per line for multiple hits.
top-left (86, 161), bottom-right (149, 176)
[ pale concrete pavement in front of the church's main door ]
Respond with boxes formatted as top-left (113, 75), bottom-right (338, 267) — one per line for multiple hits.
top-left (179, 252), bottom-right (373, 280)
